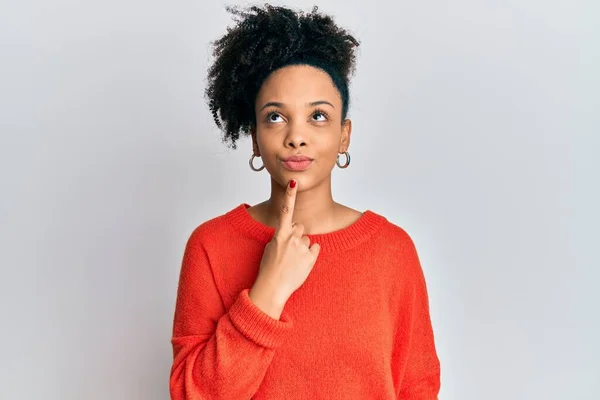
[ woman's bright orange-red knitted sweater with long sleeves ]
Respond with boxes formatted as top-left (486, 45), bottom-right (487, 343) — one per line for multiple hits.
top-left (170, 203), bottom-right (440, 400)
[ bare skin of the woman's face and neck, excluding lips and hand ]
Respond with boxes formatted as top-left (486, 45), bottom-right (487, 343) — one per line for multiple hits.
top-left (248, 65), bottom-right (362, 234)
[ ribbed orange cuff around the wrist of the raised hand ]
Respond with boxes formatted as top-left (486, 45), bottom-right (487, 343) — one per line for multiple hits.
top-left (229, 289), bottom-right (292, 349)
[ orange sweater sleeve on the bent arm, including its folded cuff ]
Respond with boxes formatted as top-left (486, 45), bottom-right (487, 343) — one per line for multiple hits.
top-left (169, 234), bottom-right (292, 400)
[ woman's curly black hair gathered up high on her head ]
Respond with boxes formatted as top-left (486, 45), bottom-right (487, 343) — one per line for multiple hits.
top-left (206, 5), bottom-right (358, 149)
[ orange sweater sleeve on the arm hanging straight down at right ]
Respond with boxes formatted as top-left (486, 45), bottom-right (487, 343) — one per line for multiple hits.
top-left (398, 236), bottom-right (440, 400)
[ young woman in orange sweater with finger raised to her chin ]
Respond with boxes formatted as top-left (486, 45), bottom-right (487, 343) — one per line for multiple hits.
top-left (170, 6), bottom-right (440, 400)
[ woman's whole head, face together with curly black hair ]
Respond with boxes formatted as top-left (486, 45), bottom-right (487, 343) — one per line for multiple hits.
top-left (206, 5), bottom-right (358, 189)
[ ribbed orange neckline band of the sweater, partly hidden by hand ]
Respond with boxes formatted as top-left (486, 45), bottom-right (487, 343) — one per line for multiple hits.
top-left (225, 203), bottom-right (386, 253)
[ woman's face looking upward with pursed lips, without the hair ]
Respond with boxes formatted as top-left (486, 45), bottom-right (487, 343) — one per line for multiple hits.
top-left (252, 65), bottom-right (351, 190)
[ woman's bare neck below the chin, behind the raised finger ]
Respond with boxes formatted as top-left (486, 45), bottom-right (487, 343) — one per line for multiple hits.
top-left (265, 176), bottom-right (339, 234)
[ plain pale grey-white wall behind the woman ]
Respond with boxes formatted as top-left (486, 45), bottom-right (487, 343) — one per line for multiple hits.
top-left (0, 0), bottom-right (600, 400)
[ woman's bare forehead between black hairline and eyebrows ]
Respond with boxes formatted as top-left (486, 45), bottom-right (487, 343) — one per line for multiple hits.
top-left (257, 65), bottom-right (341, 103)
